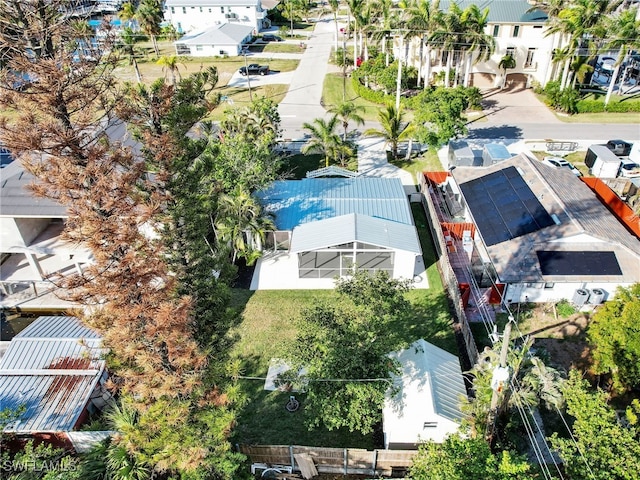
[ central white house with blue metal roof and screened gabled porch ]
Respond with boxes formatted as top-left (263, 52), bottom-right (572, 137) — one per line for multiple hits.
top-left (251, 177), bottom-right (426, 290)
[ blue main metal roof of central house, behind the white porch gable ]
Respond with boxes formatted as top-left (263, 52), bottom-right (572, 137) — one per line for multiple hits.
top-left (258, 177), bottom-right (413, 230)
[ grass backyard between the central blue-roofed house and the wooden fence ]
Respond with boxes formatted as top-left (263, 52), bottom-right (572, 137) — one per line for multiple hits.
top-left (232, 204), bottom-right (457, 449)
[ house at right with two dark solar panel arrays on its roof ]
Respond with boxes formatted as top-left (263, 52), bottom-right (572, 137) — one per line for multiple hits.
top-left (443, 154), bottom-right (640, 306)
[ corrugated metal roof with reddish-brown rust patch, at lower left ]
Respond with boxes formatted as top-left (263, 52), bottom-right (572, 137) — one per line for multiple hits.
top-left (0, 317), bottom-right (105, 432)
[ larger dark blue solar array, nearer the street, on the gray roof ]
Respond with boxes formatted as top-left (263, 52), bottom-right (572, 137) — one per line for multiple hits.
top-left (460, 167), bottom-right (554, 246)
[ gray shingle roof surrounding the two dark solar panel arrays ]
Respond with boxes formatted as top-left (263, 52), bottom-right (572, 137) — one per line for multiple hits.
top-left (452, 154), bottom-right (640, 282)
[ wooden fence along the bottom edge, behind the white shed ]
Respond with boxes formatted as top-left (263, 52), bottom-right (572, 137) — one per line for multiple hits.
top-left (238, 445), bottom-right (417, 477)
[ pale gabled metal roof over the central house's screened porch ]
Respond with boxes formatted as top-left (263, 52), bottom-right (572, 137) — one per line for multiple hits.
top-left (291, 213), bottom-right (422, 255)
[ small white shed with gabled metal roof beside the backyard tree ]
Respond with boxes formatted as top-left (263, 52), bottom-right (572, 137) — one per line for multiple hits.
top-left (382, 339), bottom-right (466, 449)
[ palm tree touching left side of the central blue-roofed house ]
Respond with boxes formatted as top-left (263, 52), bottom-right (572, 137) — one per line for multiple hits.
top-left (215, 187), bottom-right (275, 265)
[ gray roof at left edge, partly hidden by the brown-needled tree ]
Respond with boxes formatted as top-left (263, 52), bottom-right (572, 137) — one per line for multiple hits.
top-left (0, 164), bottom-right (68, 218)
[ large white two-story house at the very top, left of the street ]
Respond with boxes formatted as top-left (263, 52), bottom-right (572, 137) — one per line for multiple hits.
top-left (164, 0), bottom-right (269, 33)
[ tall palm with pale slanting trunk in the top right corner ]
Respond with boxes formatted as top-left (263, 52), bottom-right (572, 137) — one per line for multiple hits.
top-left (604, 7), bottom-right (640, 105)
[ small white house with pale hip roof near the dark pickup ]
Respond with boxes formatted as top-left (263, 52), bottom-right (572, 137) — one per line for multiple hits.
top-left (175, 23), bottom-right (253, 57)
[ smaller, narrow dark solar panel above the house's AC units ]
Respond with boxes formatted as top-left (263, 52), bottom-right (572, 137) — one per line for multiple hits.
top-left (536, 250), bottom-right (622, 276)
